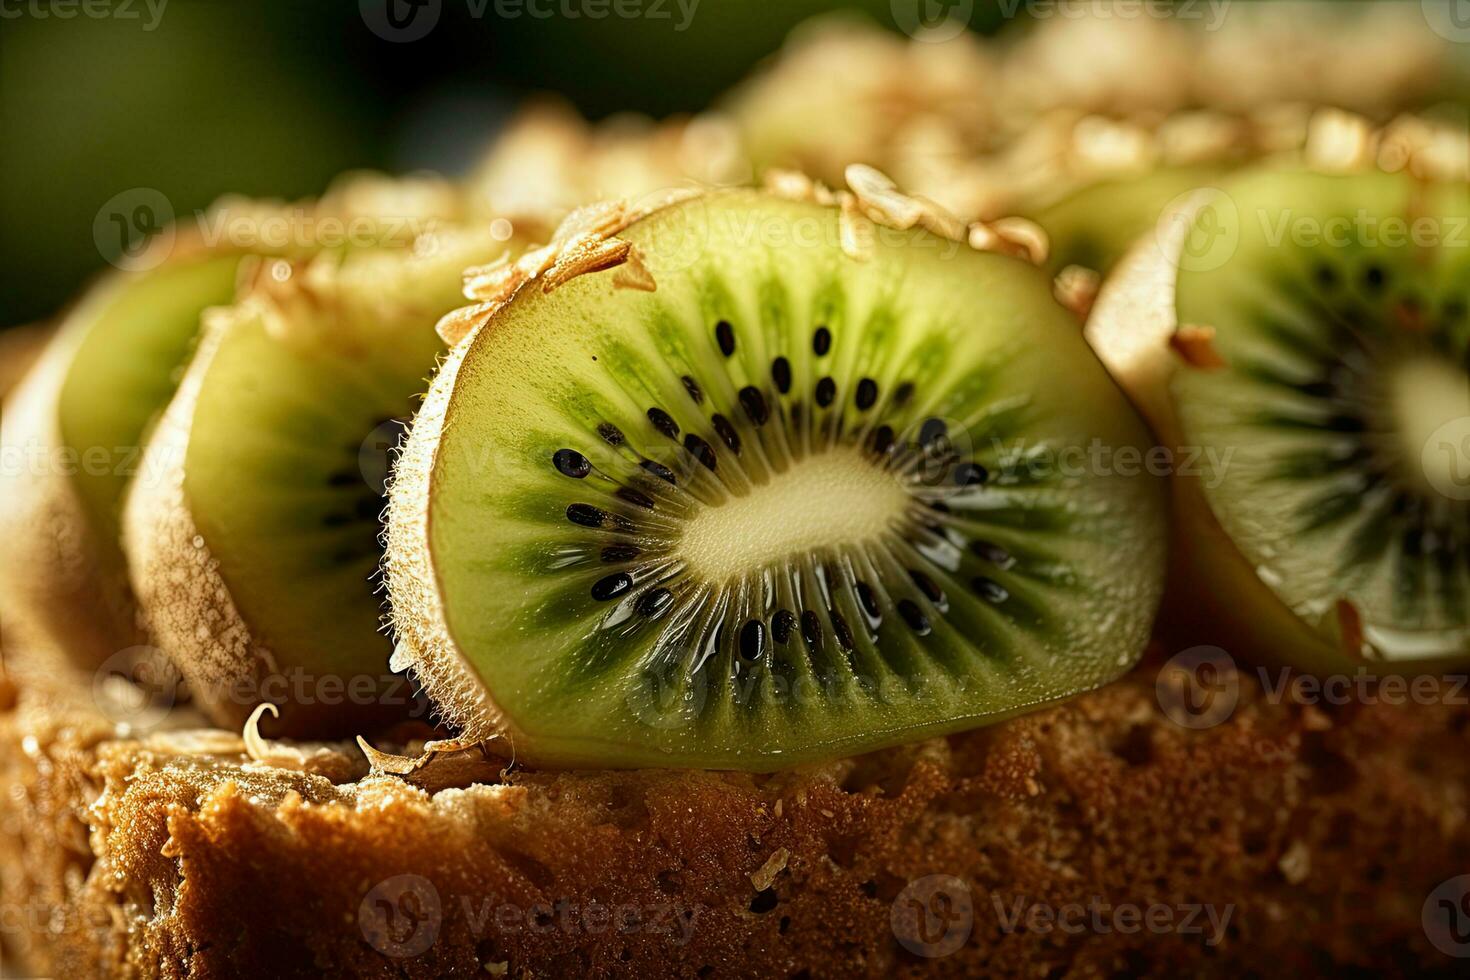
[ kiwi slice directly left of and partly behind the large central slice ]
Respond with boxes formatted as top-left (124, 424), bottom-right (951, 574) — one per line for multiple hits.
top-left (125, 228), bottom-right (507, 736)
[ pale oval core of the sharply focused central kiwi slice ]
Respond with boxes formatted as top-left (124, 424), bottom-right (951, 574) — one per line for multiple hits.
top-left (678, 448), bottom-right (913, 582)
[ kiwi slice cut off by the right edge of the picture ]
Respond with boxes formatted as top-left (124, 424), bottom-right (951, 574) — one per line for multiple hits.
top-left (1088, 169), bottom-right (1470, 671)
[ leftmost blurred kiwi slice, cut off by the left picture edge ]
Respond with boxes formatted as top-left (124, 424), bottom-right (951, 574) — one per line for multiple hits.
top-left (0, 254), bottom-right (240, 666)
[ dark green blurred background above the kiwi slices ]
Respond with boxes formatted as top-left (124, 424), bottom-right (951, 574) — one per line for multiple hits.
top-left (0, 0), bottom-right (1029, 326)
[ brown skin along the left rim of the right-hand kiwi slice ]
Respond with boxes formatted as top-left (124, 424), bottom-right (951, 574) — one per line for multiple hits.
top-left (1085, 190), bottom-right (1446, 674)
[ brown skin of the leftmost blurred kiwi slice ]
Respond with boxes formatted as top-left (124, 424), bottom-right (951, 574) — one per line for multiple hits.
top-left (0, 331), bottom-right (144, 669)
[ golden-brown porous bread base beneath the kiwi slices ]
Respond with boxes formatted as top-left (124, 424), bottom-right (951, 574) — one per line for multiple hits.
top-left (0, 655), bottom-right (1470, 979)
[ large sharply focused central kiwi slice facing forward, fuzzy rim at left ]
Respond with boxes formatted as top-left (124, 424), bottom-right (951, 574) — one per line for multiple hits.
top-left (388, 192), bottom-right (1164, 770)
